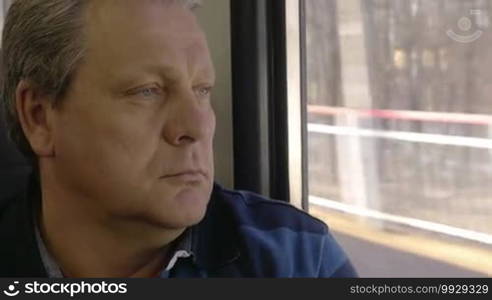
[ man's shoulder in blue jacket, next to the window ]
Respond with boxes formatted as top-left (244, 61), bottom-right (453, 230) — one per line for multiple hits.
top-left (213, 188), bottom-right (351, 277)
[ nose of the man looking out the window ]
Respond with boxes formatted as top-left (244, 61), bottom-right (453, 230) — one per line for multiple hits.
top-left (163, 92), bottom-right (215, 146)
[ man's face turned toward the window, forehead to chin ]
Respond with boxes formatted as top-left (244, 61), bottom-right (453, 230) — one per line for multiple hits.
top-left (50, 0), bottom-right (215, 228)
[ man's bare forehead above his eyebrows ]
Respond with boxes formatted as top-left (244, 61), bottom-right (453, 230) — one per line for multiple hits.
top-left (82, 0), bottom-right (212, 78)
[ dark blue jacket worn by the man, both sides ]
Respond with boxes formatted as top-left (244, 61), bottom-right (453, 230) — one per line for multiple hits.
top-left (0, 178), bottom-right (356, 278)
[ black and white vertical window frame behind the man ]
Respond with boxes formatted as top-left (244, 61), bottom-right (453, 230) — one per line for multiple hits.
top-left (231, 0), bottom-right (308, 209)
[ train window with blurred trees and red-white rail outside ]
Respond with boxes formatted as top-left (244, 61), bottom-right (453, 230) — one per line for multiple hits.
top-left (294, 0), bottom-right (492, 277)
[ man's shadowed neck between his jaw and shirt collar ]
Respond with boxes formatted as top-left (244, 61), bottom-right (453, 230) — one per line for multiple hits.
top-left (39, 176), bottom-right (184, 278)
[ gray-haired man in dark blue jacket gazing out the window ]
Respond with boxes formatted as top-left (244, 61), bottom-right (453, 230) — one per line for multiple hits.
top-left (0, 0), bottom-right (355, 278)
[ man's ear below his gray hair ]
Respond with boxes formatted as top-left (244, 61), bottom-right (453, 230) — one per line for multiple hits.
top-left (15, 80), bottom-right (54, 157)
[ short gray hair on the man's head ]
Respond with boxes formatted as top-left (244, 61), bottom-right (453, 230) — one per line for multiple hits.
top-left (0, 0), bottom-right (201, 164)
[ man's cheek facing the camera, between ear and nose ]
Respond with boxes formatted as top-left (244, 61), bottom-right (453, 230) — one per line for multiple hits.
top-left (56, 106), bottom-right (153, 175)
